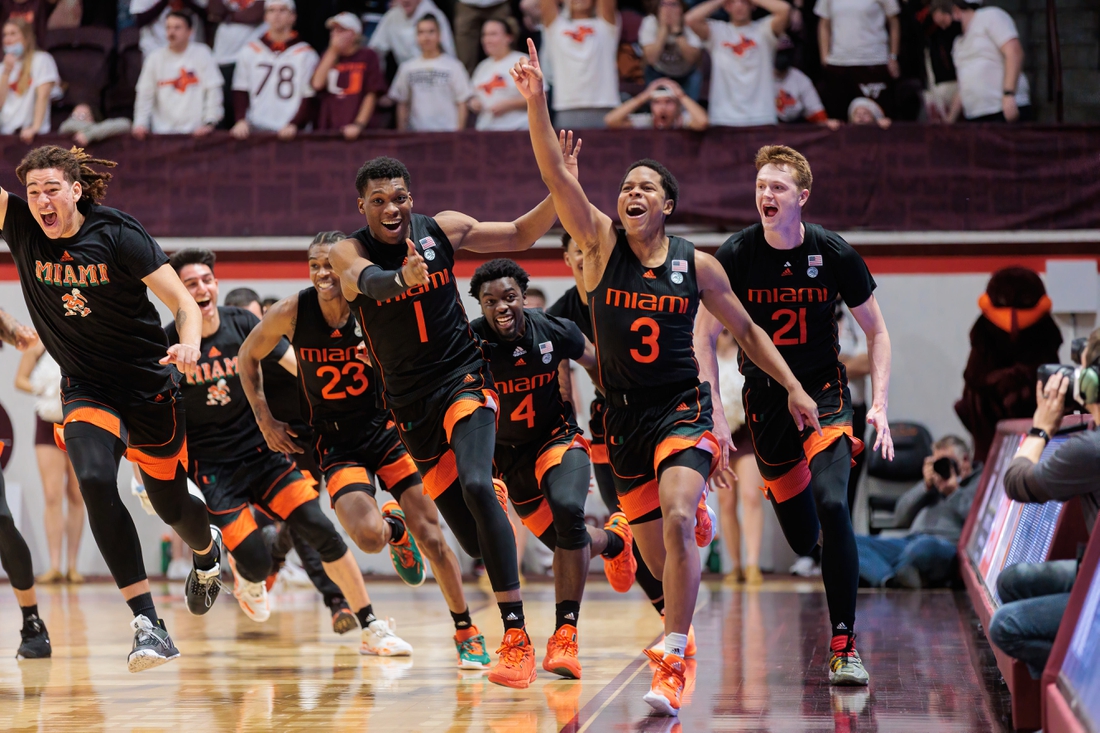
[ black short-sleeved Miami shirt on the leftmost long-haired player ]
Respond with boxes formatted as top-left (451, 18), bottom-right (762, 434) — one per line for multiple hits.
top-left (2, 192), bottom-right (174, 400)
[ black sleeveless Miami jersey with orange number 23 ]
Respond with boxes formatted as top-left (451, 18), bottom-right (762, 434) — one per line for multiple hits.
top-left (290, 287), bottom-right (377, 427)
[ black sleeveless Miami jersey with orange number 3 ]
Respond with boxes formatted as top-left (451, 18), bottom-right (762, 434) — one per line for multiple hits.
top-left (589, 230), bottom-right (699, 391)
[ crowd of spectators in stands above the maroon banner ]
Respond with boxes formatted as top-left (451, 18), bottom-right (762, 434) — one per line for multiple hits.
top-left (0, 0), bottom-right (1033, 139)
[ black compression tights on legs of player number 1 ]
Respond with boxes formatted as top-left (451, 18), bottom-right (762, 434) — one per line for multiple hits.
top-left (436, 408), bottom-right (519, 593)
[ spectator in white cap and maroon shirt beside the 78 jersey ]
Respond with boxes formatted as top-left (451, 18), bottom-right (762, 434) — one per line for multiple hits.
top-left (312, 12), bottom-right (386, 140)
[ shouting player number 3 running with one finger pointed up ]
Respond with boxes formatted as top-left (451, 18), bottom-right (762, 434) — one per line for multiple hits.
top-left (512, 43), bottom-right (817, 715)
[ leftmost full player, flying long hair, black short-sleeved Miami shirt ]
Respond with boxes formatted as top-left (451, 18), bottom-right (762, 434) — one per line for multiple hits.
top-left (0, 145), bottom-right (219, 672)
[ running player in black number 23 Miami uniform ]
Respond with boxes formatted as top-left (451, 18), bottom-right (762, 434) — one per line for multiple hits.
top-left (240, 232), bottom-right (490, 669)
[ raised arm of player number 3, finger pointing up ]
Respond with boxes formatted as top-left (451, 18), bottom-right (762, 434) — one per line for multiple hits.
top-left (512, 40), bottom-right (615, 256)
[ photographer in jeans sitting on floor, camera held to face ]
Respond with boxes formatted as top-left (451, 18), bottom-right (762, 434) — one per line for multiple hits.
top-left (856, 435), bottom-right (981, 588)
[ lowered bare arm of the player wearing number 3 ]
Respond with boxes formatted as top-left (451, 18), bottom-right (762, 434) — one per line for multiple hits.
top-left (695, 251), bottom-right (822, 435)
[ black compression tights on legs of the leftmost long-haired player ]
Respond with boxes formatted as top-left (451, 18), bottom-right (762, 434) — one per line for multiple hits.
top-left (65, 423), bottom-right (210, 588)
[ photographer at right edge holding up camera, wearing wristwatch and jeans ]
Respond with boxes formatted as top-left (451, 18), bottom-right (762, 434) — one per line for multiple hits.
top-left (989, 329), bottom-right (1100, 679)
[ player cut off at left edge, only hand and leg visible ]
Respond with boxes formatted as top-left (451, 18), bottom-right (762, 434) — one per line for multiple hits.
top-left (0, 310), bottom-right (53, 659)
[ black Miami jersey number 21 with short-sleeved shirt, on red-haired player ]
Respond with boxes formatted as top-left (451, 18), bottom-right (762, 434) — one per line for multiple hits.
top-left (715, 223), bottom-right (876, 379)
